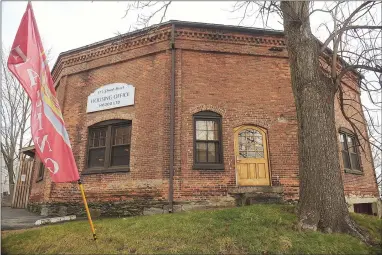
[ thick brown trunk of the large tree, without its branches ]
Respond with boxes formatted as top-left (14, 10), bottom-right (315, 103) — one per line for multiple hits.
top-left (281, 1), bottom-right (365, 240)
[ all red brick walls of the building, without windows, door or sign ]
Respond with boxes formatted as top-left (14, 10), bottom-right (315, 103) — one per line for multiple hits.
top-left (30, 23), bottom-right (377, 206)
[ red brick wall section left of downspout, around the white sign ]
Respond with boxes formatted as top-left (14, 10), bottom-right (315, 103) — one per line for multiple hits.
top-left (31, 49), bottom-right (171, 202)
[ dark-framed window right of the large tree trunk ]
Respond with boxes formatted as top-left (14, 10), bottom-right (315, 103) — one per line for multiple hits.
top-left (340, 128), bottom-right (361, 173)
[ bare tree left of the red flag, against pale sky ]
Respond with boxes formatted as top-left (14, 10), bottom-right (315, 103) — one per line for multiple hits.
top-left (0, 47), bottom-right (32, 193)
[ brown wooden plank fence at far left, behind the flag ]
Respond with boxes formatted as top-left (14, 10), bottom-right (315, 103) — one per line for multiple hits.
top-left (11, 154), bottom-right (34, 208)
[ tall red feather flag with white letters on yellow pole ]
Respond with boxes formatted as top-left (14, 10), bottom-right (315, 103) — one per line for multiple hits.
top-left (8, 2), bottom-right (79, 182)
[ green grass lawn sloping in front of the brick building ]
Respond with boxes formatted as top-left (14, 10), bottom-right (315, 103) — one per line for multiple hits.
top-left (2, 205), bottom-right (382, 254)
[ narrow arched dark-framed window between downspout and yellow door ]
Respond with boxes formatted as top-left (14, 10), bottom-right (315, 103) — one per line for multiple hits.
top-left (194, 111), bottom-right (224, 169)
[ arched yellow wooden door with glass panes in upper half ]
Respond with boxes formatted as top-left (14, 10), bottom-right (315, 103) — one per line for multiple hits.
top-left (235, 126), bottom-right (270, 186)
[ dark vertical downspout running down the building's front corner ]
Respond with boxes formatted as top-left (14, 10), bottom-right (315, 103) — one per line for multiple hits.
top-left (168, 24), bottom-right (175, 213)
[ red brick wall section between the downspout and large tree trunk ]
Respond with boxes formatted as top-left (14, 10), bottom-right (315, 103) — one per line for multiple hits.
top-left (176, 49), bottom-right (298, 200)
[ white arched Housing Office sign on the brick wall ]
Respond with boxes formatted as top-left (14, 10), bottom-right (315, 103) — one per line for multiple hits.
top-left (86, 83), bottom-right (135, 112)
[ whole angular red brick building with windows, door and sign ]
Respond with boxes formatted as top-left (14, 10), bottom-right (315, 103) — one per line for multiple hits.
top-left (22, 21), bottom-right (378, 215)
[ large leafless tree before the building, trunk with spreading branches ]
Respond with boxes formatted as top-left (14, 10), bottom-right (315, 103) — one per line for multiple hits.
top-left (124, 1), bottom-right (382, 241)
